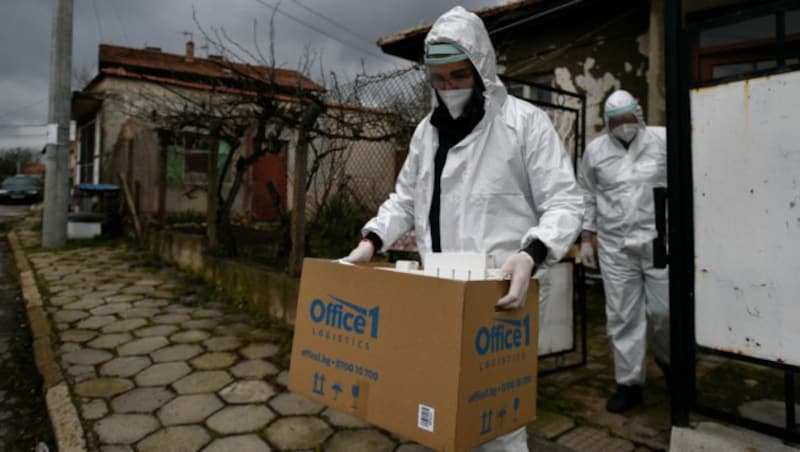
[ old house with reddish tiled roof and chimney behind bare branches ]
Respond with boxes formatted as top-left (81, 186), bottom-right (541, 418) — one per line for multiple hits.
top-left (72, 42), bottom-right (395, 221)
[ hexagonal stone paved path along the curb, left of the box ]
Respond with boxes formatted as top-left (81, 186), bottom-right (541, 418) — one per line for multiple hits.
top-left (14, 228), bottom-right (444, 452)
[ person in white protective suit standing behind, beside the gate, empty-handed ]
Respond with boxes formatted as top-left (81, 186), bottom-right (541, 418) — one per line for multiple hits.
top-left (578, 90), bottom-right (669, 413)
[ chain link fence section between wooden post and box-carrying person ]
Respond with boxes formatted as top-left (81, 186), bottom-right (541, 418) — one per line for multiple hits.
top-left (308, 66), bottom-right (430, 215)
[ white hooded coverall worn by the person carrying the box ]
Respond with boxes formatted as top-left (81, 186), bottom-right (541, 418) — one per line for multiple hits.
top-left (362, 7), bottom-right (583, 452)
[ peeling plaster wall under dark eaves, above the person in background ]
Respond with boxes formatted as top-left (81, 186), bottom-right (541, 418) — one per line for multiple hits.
top-left (493, 0), bottom-right (650, 143)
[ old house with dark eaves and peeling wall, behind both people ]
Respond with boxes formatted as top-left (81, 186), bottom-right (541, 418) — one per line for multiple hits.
top-left (378, 0), bottom-right (800, 146)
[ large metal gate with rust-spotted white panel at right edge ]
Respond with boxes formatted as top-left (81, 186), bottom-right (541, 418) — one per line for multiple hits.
top-left (662, 0), bottom-right (800, 442)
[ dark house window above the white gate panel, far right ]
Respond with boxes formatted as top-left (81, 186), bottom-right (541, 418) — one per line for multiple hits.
top-left (694, 6), bottom-right (800, 82)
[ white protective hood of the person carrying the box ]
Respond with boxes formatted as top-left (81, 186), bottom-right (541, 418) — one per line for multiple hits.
top-left (425, 6), bottom-right (507, 112)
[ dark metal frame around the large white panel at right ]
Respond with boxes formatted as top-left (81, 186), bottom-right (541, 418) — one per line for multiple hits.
top-left (664, 0), bottom-right (800, 442)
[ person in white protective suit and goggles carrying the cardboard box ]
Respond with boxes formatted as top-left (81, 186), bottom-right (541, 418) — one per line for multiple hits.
top-left (344, 7), bottom-right (583, 452)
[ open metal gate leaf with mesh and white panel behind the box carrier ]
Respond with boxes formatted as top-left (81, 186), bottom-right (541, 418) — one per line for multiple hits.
top-left (500, 75), bottom-right (587, 375)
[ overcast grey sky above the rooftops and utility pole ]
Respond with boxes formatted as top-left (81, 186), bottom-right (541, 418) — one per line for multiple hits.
top-left (0, 0), bottom-right (507, 149)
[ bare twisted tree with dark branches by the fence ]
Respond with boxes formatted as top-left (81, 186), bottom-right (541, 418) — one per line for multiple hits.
top-left (125, 12), bottom-right (416, 275)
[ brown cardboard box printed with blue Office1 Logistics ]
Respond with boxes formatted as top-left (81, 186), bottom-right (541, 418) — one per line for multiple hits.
top-left (289, 259), bottom-right (539, 452)
